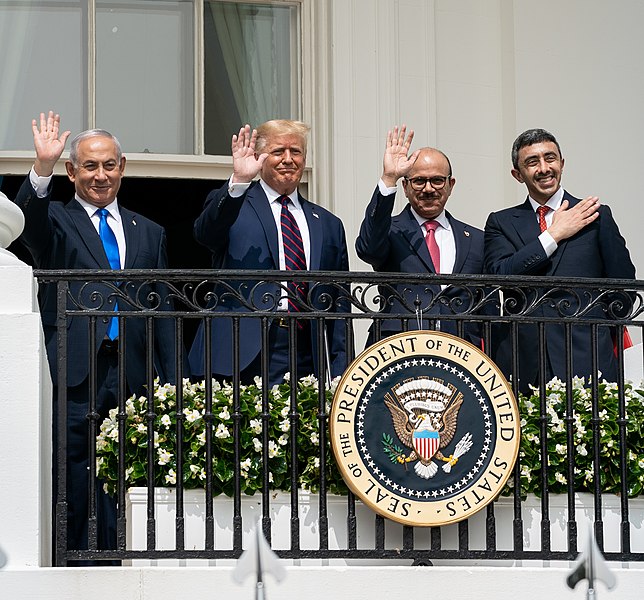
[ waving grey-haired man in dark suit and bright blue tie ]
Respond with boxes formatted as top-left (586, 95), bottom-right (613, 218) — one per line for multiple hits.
top-left (15, 111), bottom-right (175, 550)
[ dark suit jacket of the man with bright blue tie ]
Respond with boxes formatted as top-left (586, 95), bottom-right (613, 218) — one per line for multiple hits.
top-left (15, 177), bottom-right (175, 393)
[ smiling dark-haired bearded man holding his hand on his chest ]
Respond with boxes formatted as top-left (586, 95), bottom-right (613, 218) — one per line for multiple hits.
top-left (485, 129), bottom-right (635, 392)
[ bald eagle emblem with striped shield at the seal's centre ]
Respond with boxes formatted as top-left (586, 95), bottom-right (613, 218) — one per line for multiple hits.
top-left (384, 377), bottom-right (472, 479)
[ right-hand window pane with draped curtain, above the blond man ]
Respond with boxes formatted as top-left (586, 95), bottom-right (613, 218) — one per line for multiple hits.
top-left (204, 0), bottom-right (300, 154)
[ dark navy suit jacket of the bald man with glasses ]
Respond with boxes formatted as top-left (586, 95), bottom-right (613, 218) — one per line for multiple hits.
top-left (356, 187), bottom-right (483, 346)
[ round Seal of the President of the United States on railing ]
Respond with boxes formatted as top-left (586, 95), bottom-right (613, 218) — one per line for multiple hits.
top-left (330, 331), bottom-right (520, 527)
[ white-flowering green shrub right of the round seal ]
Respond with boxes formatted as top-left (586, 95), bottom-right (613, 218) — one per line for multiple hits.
top-left (505, 377), bottom-right (644, 497)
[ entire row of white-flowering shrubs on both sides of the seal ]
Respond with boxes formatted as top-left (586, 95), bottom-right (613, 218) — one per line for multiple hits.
top-left (96, 376), bottom-right (644, 496)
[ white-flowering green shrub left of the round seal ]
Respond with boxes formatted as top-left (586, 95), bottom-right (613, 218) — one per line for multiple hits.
top-left (96, 376), bottom-right (346, 496)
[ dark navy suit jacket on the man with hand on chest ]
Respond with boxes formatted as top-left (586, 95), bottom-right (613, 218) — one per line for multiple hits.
top-left (485, 192), bottom-right (635, 391)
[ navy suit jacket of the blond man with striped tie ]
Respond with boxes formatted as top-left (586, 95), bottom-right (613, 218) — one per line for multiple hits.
top-left (190, 182), bottom-right (349, 376)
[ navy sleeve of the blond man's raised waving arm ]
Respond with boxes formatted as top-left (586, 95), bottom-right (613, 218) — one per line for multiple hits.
top-left (194, 184), bottom-right (245, 266)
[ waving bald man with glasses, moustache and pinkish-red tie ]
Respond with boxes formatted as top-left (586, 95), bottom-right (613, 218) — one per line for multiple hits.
top-left (356, 125), bottom-right (483, 345)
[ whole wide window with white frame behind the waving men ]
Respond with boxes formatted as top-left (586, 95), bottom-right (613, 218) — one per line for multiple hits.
top-left (0, 0), bottom-right (303, 156)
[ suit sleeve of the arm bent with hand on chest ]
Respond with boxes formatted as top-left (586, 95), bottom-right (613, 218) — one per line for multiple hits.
top-left (483, 213), bottom-right (549, 275)
